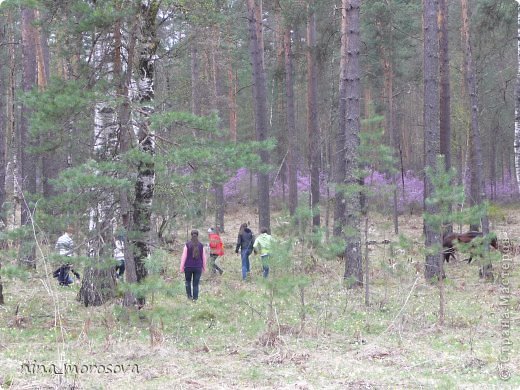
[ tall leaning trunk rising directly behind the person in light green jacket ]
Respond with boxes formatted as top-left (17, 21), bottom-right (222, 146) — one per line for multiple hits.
top-left (247, 0), bottom-right (271, 229)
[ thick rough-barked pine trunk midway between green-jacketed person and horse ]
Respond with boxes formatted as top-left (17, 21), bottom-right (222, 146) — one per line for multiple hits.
top-left (340, 0), bottom-right (363, 286)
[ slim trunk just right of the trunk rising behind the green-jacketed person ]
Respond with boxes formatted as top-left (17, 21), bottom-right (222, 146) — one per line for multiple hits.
top-left (284, 26), bottom-right (298, 216)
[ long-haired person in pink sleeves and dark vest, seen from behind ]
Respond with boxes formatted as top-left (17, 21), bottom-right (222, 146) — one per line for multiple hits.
top-left (180, 230), bottom-right (206, 301)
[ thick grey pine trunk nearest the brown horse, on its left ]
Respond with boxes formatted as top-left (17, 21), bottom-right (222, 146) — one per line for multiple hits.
top-left (423, 0), bottom-right (441, 280)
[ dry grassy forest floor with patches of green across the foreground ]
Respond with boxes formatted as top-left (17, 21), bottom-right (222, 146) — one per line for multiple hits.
top-left (0, 206), bottom-right (520, 389)
